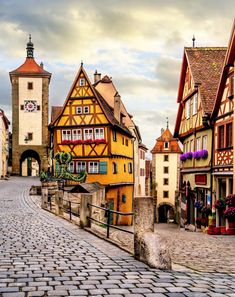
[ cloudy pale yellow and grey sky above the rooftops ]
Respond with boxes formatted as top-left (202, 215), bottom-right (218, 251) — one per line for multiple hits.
top-left (0, 0), bottom-right (235, 157)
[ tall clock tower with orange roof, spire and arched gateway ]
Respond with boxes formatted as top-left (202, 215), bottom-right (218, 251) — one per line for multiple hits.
top-left (9, 36), bottom-right (51, 176)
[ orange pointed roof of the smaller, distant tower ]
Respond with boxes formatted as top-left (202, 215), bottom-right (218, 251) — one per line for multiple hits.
top-left (151, 128), bottom-right (182, 154)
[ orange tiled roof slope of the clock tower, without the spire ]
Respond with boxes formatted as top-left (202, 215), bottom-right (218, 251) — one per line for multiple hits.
top-left (10, 58), bottom-right (51, 76)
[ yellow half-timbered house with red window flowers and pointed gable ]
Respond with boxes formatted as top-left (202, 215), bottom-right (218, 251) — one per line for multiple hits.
top-left (50, 65), bottom-right (134, 224)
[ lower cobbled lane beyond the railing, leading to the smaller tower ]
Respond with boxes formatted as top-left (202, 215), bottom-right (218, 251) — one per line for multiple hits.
top-left (106, 224), bottom-right (235, 273)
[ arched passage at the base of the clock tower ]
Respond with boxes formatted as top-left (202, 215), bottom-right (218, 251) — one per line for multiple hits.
top-left (20, 150), bottom-right (41, 176)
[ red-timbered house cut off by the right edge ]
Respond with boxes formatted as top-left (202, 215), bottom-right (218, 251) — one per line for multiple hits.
top-left (211, 22), bottom-right (235, 198)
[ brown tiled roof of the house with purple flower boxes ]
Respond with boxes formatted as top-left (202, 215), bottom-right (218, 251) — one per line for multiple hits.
top-left (185, 47), bottom-right (227, 113)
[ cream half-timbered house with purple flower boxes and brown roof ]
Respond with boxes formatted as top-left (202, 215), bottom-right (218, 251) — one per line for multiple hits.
top-left (174, 47), bottom-right (226, 228)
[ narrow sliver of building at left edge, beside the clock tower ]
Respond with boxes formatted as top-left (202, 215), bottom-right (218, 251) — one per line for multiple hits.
top-left (0, 109), bottom-right (10, 178)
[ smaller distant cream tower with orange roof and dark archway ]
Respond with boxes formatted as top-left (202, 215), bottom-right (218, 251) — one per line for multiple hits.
top-left (151, 128), bottom-right (181, 223)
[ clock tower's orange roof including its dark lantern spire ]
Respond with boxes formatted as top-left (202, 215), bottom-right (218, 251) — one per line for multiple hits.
top-left (9, 35), bottom-right (51, 78)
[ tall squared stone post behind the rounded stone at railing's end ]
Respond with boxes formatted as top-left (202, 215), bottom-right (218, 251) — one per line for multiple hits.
top-left (134, 197), bottom-right (154, 260)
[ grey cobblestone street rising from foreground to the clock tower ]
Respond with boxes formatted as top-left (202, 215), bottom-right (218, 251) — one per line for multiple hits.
top-left (0, 178), bottom-right (235, 297)
